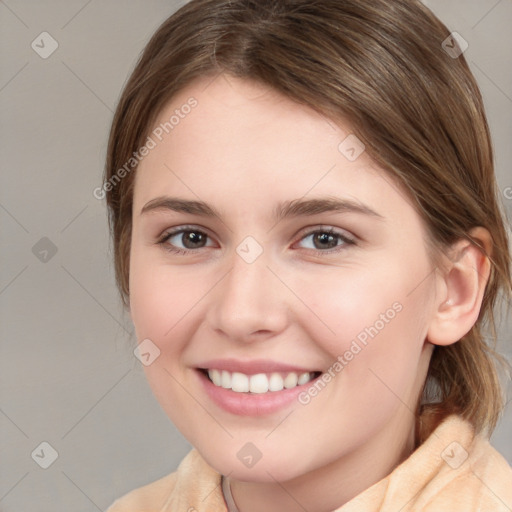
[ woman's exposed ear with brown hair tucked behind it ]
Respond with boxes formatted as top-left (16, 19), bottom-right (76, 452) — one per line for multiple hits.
top-left (427, 227), bottom-right (492, 345)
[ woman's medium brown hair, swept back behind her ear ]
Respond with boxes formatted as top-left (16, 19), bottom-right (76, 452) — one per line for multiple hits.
top-left (104, 0), bottom-right (512, 441)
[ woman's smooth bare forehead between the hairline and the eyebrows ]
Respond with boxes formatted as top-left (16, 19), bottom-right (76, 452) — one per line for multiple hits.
top-left (134, 75), bottom-right (416, 222)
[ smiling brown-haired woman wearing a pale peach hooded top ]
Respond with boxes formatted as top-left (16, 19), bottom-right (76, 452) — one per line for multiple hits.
top-left (103, 0), bottom-right (512, 512)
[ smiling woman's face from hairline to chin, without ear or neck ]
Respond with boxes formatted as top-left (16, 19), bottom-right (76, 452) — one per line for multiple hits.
top-left (130, 75), bottom-right (435, 482)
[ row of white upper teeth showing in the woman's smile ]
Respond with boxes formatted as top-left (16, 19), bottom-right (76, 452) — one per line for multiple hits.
top-left (208, 369), bottom-right (314, 394)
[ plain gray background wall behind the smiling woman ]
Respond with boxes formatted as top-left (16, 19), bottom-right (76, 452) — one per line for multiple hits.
top-left (0, 0), bottom-right (512, 512)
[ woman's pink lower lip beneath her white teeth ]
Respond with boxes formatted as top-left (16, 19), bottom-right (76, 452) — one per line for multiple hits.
top-left (196, 370), bottom-right (320, 416)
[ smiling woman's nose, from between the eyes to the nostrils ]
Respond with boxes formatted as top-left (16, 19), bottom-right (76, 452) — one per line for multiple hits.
top-left (208, 245), bottom-right (291, 343)
